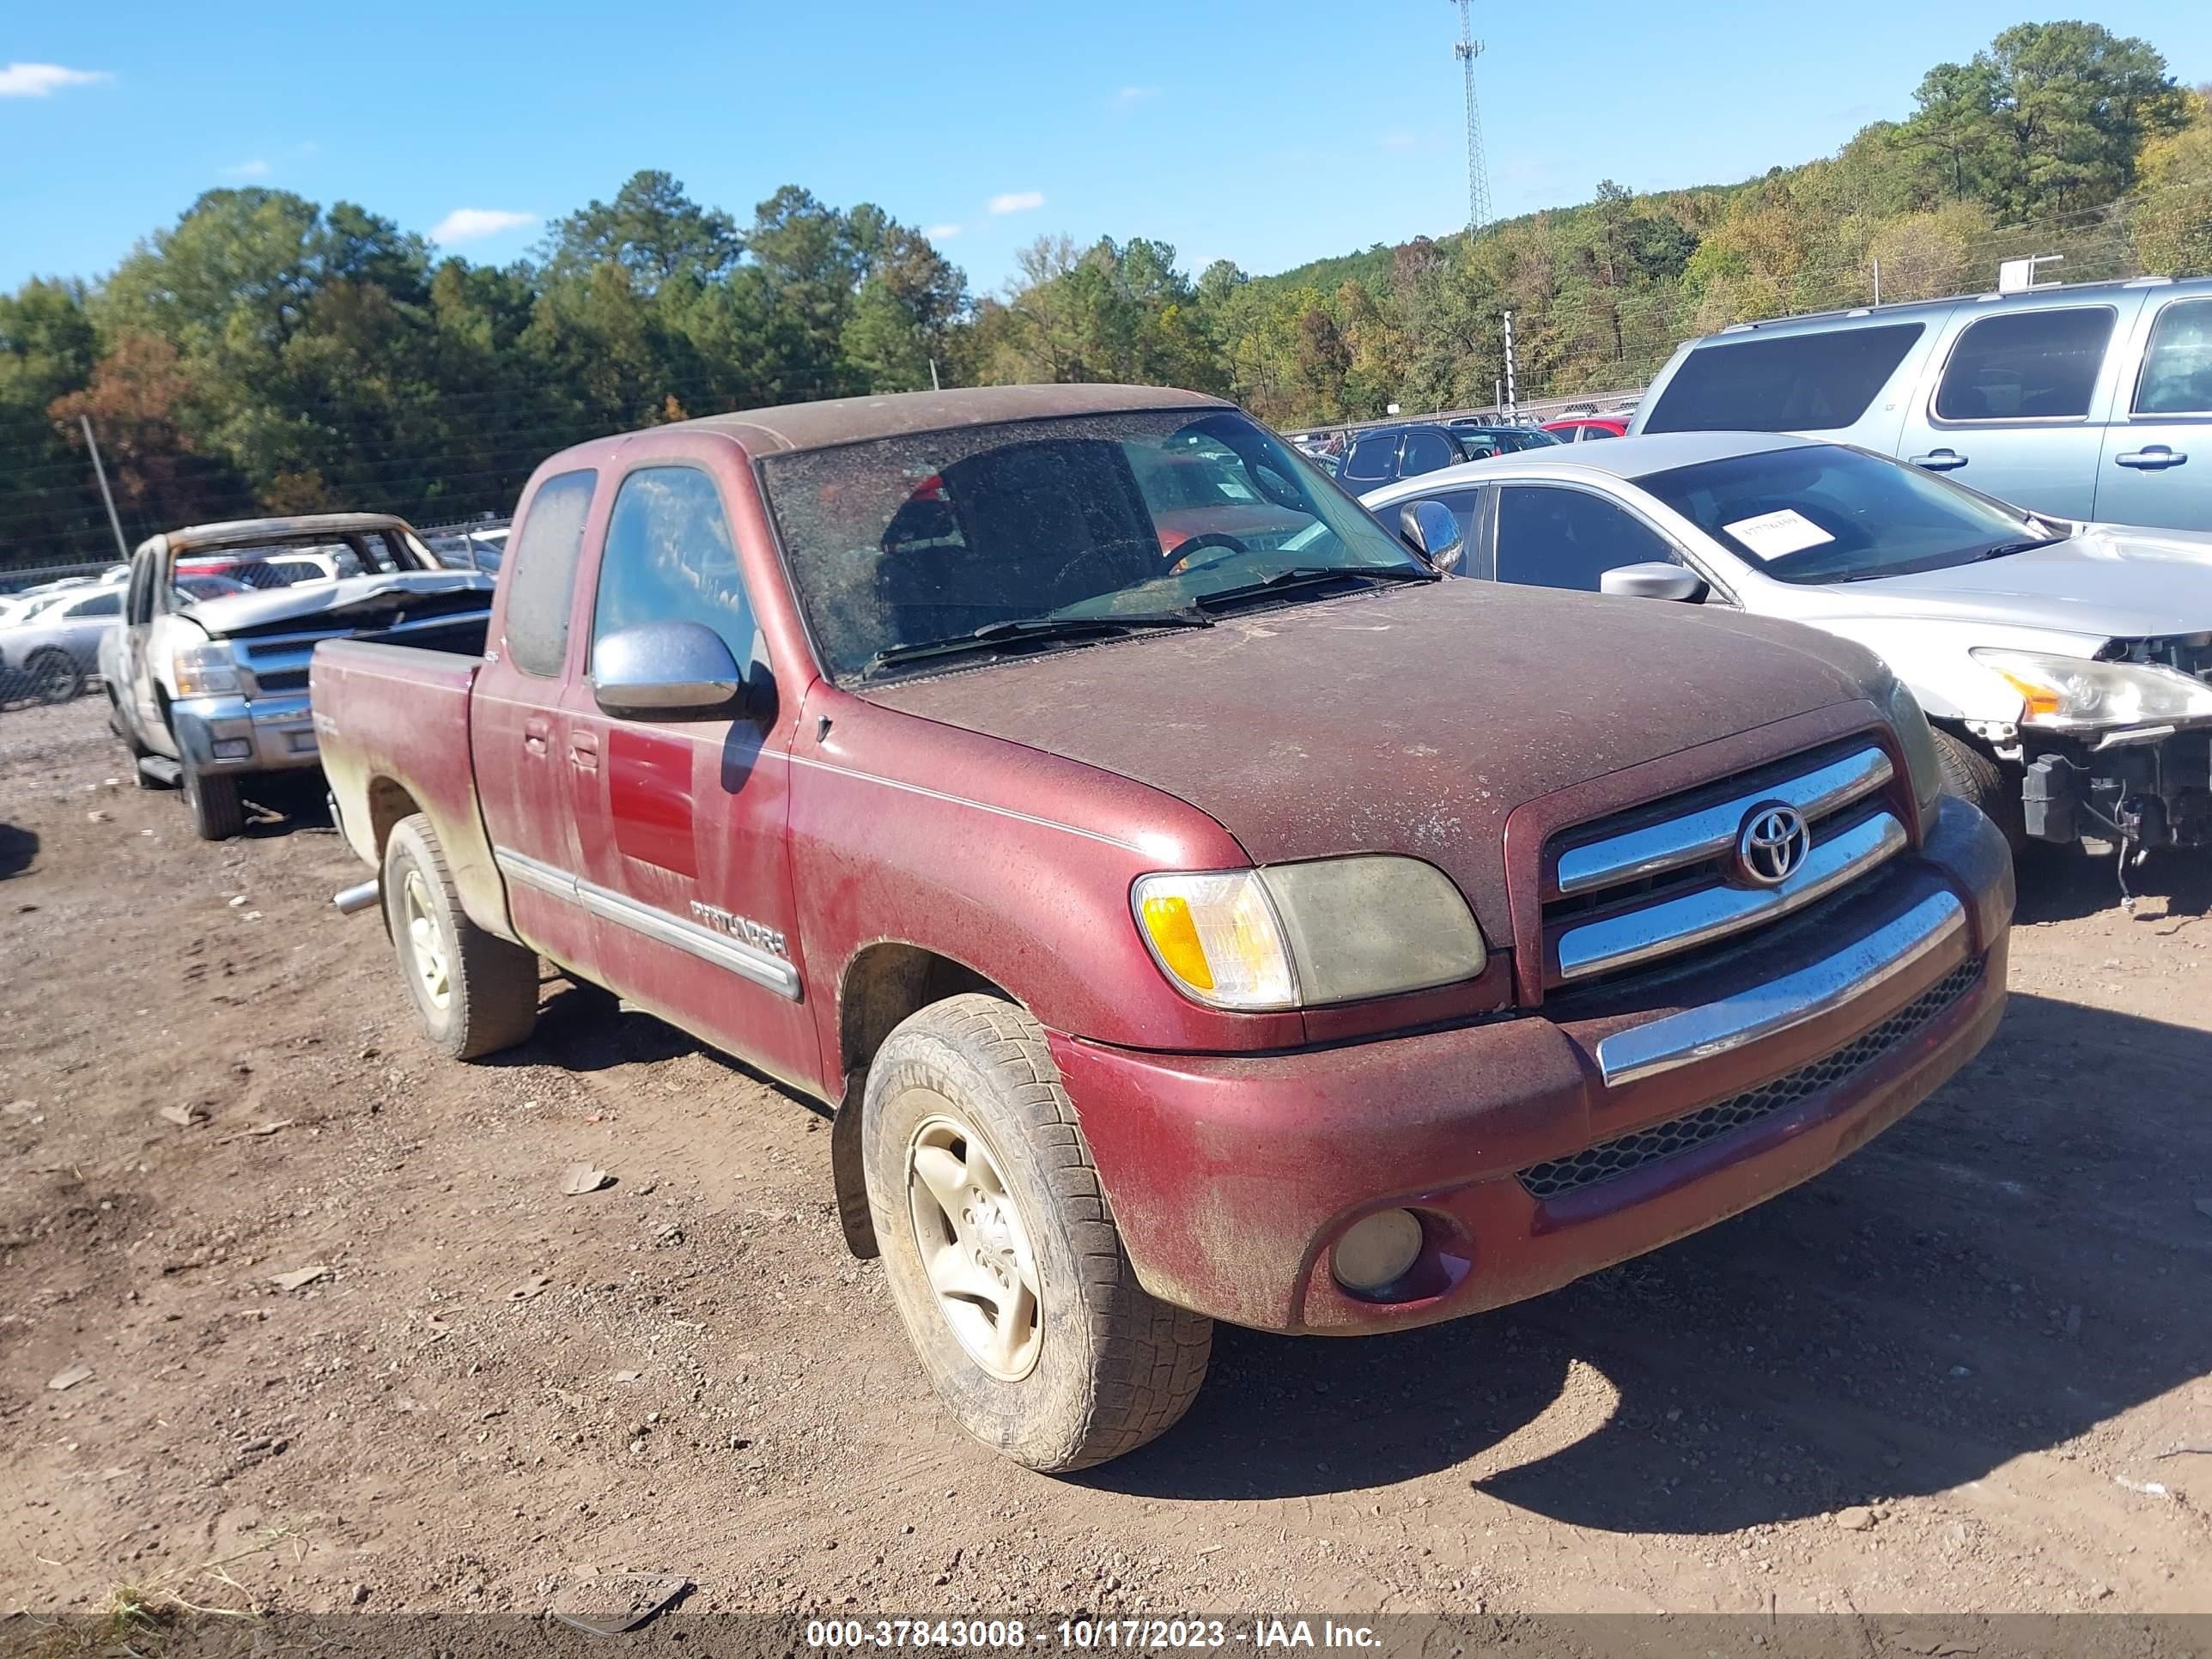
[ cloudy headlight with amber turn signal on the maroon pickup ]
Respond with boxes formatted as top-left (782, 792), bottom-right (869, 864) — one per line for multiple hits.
top-left (1133, 854), bottom-right (1489, 1009)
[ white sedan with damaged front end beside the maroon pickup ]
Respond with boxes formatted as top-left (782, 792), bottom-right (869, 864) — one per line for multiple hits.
top-left (1363, 431), bottom-right (2212, 880)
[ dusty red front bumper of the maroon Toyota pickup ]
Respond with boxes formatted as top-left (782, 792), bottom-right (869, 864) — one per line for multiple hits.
top-left (1051, 799), bottom-right (2013, 1334)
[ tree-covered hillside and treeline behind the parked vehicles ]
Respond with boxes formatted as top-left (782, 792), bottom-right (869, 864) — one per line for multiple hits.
top-left (0, 22), bottom-right (2212, 566)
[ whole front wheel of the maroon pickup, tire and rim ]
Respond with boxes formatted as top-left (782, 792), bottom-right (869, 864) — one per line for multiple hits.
top-left (860, 995), bottom-right (1212, 1474)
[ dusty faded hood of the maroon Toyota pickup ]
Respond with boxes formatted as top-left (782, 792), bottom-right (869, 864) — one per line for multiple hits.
top-left (863, 580), bottom-right (1874, 940)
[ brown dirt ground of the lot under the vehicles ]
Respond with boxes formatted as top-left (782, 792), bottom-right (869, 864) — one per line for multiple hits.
top-left (0, 699), bottom-right (2212, 1614)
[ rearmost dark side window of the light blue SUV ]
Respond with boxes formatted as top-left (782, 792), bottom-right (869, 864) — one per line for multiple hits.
top-left (1645, 323), bottom-right (1927, 435)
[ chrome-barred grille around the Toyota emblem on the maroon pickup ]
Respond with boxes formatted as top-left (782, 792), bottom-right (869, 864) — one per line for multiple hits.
top-left (1544, 741), bottom-right (1909, 984)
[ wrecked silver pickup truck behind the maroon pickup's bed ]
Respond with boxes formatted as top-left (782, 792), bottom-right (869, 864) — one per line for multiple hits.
top-left (100, 514), bottom-right (491, 841)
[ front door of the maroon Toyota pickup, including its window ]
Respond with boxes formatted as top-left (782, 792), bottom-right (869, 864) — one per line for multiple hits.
top-left (571, 462), bottom-right (821, 1082)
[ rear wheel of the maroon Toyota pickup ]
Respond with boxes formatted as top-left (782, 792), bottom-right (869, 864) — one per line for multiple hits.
top-left (383, 811), bottom-right (538, 1060)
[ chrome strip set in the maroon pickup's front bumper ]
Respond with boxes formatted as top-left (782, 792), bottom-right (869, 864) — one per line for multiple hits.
top-left (1597, 894), bottom-right (1966, 1088)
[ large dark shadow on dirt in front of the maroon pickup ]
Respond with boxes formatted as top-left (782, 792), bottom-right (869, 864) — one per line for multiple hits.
top-left (1082, 995), bottom-right (2212, 1533)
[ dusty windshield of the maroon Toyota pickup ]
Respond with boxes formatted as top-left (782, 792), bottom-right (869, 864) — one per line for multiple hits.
top-left (761, 410), bottom-right (1429, 679)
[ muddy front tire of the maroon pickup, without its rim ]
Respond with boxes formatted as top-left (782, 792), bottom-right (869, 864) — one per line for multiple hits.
top-left (860, 995), bottom-right (1212, 1474)
